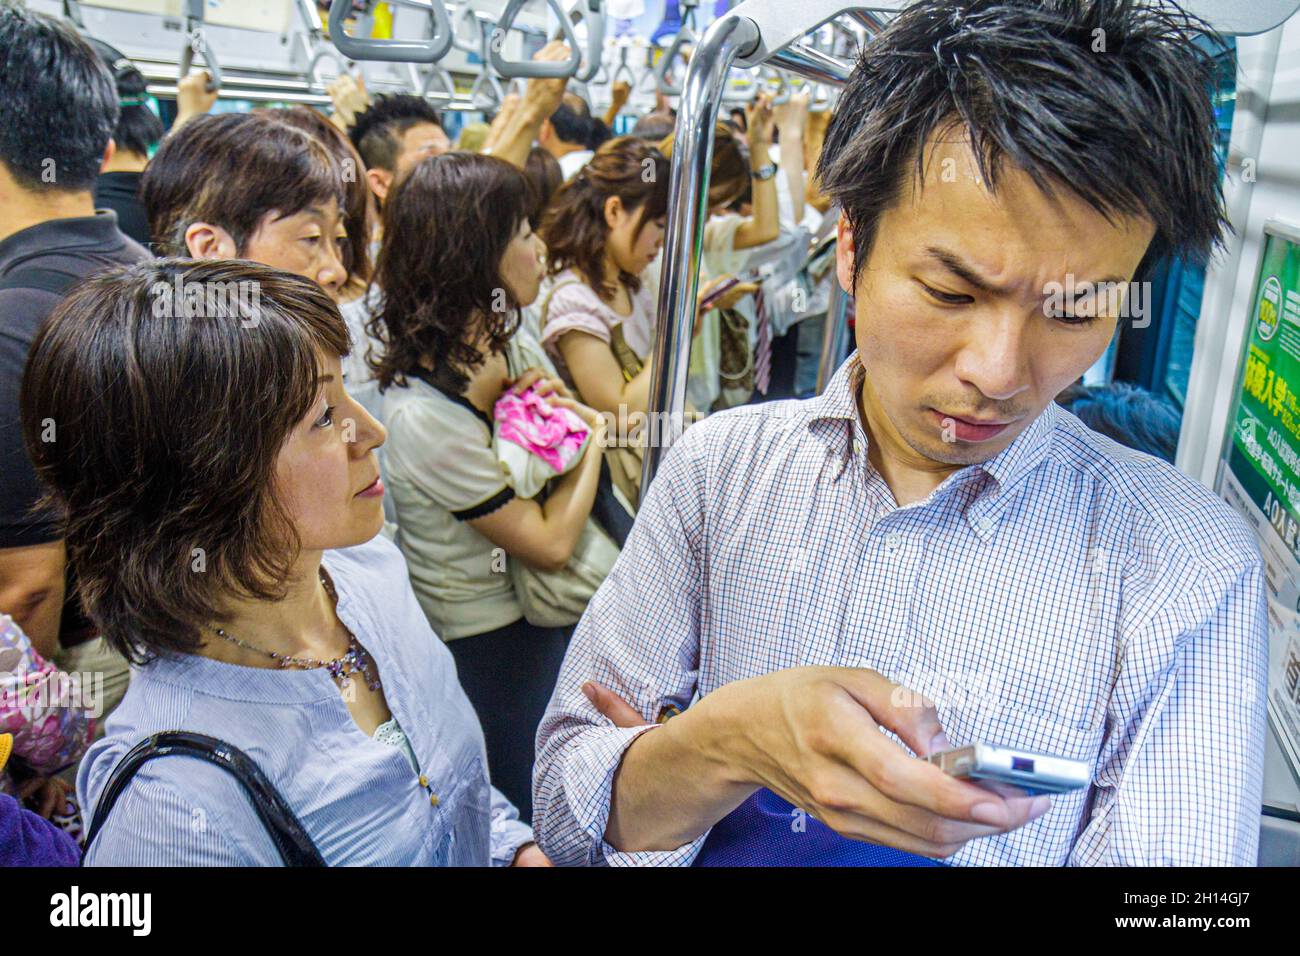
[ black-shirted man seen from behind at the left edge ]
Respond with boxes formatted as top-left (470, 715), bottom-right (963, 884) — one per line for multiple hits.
top-left (0, 1), bottom-right (148, 683)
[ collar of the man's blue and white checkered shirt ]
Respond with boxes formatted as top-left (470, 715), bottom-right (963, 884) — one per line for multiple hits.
top-left (809, 351), bottom-right (1060, 537)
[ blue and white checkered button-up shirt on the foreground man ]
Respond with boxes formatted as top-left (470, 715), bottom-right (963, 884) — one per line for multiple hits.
top-left (533, 355), bottom-right (1268, 865)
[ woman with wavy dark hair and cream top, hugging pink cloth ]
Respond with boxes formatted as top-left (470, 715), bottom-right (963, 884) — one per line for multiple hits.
top-left (371, 152), bottom-right (605, 817)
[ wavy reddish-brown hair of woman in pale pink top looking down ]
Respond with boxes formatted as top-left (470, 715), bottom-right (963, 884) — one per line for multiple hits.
top-left (540, 137), bottom-right (668, 299)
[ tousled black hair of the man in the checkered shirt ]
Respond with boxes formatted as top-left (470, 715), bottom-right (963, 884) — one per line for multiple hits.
top-left (818, 0), bottom-right (1227, 291)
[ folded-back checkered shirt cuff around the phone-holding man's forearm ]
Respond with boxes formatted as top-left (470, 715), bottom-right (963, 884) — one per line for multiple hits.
top-left (566, 723), bottom-right (709, 866)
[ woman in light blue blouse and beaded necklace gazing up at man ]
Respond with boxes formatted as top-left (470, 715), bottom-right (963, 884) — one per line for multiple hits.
top-left (22, 260), bottom-right (546, 865)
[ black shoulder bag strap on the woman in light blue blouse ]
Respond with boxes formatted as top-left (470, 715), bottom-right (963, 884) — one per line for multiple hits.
top-left (86, 731), bottom-right (325, 866)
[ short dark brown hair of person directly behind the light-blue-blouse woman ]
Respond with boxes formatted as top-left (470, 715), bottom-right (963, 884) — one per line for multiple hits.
top-left (140, 111), bottom-right (347, 256)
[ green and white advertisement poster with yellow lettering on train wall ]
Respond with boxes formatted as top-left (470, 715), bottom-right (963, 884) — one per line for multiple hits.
top-left (1216, 222), bottom-right (1300, 774)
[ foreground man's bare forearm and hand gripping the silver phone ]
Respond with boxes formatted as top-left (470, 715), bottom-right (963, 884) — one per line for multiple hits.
top-left (606, 667), bottom-right (1052, 857)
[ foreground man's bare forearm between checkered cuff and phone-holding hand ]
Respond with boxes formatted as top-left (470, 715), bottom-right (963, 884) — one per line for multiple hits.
top-left (605, 688), bottom-right (757, 853)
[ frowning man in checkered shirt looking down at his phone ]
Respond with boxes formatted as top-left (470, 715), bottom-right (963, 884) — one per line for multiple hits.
top-left (534, 0), bottom-right (1266, 865)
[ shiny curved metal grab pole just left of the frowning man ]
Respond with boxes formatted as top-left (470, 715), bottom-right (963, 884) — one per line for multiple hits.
top-left (641, 16), bottom-right (759, 498)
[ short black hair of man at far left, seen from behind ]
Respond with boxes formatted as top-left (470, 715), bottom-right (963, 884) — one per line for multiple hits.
top-left (0, 0), bottom-right (120, 193)
